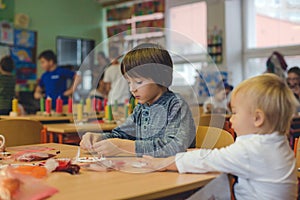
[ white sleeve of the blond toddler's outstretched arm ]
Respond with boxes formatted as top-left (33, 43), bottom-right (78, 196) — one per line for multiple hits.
top-left (175, 142), bottom-right (253, 177)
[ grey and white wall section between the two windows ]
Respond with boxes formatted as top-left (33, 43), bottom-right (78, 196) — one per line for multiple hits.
top-left (207, 0), bottom-right (243, 85)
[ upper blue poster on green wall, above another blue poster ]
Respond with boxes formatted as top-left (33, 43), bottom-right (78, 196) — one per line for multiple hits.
top-left (14, 29), bottom-right (35, 48)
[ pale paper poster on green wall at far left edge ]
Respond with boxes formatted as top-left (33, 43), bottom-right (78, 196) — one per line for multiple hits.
top-left (0, 21), bottom-right (14, 45)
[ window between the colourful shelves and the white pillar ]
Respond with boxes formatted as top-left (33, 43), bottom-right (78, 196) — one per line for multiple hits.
top-left (166, 0), bottom-right (207, 87)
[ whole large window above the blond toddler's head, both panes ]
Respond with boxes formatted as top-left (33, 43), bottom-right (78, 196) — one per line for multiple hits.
top-left (243, 0), bottom-right (300, 78)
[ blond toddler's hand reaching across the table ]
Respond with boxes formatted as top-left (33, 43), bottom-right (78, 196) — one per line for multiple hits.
top-left (141, 155), bottom-right (177, 172)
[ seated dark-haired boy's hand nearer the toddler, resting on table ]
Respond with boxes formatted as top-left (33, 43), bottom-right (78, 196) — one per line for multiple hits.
top-left (92, 138), bottom-right (123, 156)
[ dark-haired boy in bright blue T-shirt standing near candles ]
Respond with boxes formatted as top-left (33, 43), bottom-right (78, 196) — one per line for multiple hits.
top-left (34, 50), bottom-right (80, 108)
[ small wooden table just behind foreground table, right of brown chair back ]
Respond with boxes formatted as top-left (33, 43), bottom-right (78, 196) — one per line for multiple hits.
top-left (41, 123), bottom-right (117, 144)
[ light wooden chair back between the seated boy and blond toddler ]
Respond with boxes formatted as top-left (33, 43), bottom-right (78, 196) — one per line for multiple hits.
top-left (196, 126), bottom-right (234, 149)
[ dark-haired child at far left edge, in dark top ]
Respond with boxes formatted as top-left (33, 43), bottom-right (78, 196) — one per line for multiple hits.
top-left (0, 56), bottom-right (16, 115)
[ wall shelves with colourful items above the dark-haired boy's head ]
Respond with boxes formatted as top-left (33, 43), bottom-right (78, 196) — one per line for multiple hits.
top-left (104, 0), bottom-right (165, 55)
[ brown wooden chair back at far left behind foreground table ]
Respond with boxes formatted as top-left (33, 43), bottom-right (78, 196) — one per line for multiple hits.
top-left (0, 119), bottom-right (43, 147)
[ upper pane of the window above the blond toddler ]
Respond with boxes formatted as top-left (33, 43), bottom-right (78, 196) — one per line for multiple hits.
top-left (248, 0), bottom-right (300, 48)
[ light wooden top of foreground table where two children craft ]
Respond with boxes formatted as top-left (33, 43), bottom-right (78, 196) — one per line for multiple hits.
top-left (8, 143), bottom-right (218, 200)
